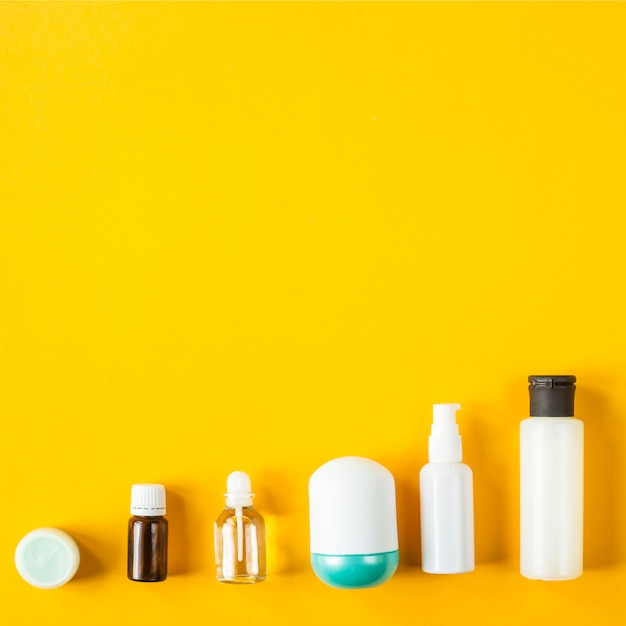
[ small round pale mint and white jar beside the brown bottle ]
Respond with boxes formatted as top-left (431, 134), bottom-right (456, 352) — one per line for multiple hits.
top-left (15, 528), bottom-right (80, 589)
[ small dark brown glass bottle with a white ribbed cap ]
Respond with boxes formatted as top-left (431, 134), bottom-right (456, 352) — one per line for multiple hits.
top-left (128, 484), bottom-right (167, 583)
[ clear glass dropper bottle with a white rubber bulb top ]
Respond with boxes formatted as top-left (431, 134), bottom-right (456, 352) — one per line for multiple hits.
top-left (215, 472), bottom-right (267, 583)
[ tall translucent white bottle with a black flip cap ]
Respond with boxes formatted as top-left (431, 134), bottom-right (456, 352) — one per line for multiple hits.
top-left (520, 376), bottom-right (584, 580)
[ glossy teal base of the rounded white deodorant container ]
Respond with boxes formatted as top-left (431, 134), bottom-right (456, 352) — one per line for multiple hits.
top-left (311, 550), bottom-right (399, 589)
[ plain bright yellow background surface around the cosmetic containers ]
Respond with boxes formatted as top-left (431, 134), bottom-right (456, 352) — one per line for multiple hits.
top-left (0, 3), bottom-right (626, 625)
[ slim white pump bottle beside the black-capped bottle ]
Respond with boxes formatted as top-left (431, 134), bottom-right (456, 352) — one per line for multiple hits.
top-left (420, 404), bottom-right (474, 574)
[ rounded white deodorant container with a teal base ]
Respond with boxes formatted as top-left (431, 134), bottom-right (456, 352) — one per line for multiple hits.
top-left (309, 456), bottom-right (398, 589)
